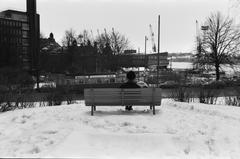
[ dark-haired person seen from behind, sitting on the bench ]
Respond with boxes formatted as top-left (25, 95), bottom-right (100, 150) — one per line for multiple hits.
top-left (120, 71), bottom-right (141, 111)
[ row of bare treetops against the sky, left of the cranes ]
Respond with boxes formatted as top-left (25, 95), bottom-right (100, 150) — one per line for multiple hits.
top-left (62, 29), bottom-right (130, 55)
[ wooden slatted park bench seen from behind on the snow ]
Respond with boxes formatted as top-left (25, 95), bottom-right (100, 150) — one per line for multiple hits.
top-left (84, 88), bottom-right (162, 116)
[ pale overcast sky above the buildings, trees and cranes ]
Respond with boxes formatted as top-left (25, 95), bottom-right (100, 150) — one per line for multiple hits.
top-left (0, 0), bottom-right (240, 52)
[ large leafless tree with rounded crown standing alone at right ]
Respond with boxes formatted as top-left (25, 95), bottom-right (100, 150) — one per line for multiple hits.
top-left (197, 12), bottom-right (240, 80)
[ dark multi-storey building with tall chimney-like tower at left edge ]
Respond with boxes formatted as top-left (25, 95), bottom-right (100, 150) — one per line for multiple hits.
top-left (0, 0), bottom-right (40, 73)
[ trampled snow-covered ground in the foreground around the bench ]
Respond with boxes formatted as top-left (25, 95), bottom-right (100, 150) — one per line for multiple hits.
top-left (0, 99), bottom-right (240, 159)
